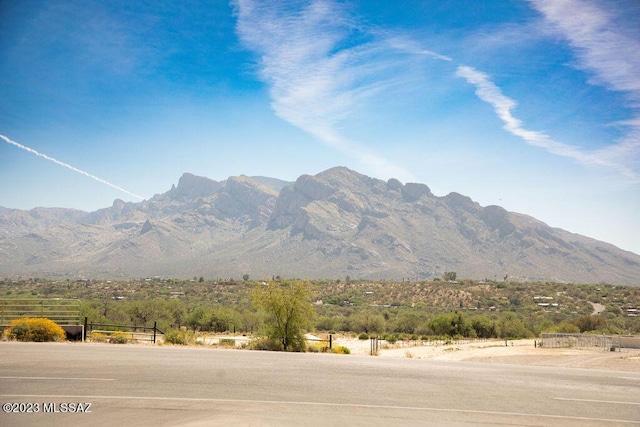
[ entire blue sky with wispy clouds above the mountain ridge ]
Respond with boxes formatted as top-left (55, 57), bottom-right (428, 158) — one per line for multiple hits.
top-left (0, 0), bottom-right (640, 253)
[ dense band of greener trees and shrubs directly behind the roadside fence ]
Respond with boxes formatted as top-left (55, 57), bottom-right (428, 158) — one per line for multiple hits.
top-left (76, 280), bottom-right (640, 350)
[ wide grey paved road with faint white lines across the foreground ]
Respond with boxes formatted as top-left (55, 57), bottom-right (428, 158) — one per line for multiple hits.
top-left (0, 343), bottom-right (640, 427)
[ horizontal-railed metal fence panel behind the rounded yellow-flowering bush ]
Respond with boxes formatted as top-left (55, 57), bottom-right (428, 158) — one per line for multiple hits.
top-left (0, 298), bottom-right (82, 326)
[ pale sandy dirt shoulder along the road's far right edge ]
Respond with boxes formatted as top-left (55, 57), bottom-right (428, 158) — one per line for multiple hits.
top-left (335, 337), bottom-right (640, 372)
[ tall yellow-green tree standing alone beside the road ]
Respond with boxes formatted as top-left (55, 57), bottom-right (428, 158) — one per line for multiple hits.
top-left (252, 280), bottom-right (314, 351)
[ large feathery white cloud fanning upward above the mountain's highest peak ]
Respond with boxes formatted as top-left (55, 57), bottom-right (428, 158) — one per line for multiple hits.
top-left (235, 0), bottom-right (450, 178)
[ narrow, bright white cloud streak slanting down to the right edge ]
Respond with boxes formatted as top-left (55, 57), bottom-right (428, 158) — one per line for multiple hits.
top-left (456, 66), bottom-right (638, 179)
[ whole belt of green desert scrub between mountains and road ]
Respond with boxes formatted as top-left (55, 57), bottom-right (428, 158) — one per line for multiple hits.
top-left (0, 275), bottom-right (640, 351)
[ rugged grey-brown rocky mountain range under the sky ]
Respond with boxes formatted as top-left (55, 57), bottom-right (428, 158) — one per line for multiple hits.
top-left (0, 167), bottom-right (640, 286)
